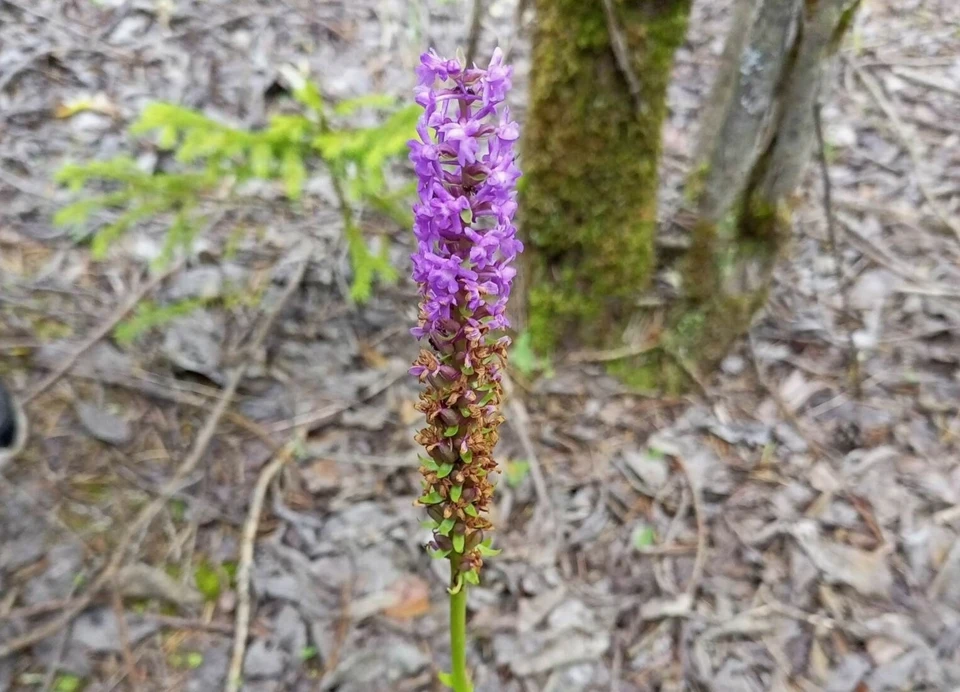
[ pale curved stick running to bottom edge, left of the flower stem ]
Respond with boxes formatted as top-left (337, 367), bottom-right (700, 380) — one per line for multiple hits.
top-left (223, 442), bottom-right (296, 692)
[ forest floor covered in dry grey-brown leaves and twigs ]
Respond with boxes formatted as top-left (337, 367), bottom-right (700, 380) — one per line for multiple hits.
top-left (0, 0), bottom-right (960, 692)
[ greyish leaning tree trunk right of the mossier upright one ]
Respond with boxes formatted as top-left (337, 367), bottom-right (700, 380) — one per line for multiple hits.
top-left (671, 0), bottom-right (859, 373)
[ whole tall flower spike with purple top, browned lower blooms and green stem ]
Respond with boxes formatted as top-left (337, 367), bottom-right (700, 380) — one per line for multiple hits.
top-left (410, 49), bottom-right (523, 692)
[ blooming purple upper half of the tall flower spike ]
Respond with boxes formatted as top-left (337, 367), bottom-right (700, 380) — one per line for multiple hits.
top-left (410, 48), bottom-right (523, 340)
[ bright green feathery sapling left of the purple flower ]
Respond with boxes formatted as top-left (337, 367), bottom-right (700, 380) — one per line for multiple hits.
top-left (54, 70), bottom-right (419, 301)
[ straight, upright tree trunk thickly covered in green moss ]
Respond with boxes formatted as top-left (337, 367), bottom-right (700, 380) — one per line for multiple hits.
top-left (521, 0), bottom-right (690, 351)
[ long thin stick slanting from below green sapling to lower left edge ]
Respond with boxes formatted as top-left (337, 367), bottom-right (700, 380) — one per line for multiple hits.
top-left (0, 247), bottom-right (309, 659)
